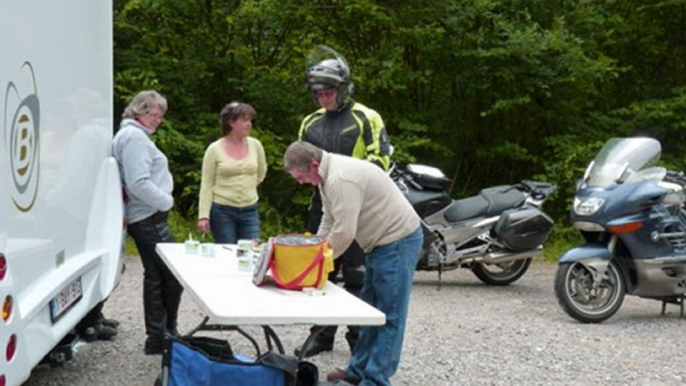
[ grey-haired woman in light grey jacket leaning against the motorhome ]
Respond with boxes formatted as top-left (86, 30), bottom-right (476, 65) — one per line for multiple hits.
top-left (112, 90), bottom-right (183, 355)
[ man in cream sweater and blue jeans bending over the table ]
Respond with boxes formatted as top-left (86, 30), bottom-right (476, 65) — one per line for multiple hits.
top-left (284, 142), bottom-right (423, 386)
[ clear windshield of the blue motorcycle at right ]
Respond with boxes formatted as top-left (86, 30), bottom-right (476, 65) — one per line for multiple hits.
top-left (586, 138), bottom-right (662, 187)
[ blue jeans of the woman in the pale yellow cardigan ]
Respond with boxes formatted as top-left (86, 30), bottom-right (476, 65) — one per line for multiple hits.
top-left (210, 202), bottom-right (260, 244)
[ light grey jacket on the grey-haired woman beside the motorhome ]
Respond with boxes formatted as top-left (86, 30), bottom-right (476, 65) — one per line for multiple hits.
top-left (112, 119), bottom-right (174, 224)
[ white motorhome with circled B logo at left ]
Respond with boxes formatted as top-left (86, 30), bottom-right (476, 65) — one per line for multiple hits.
top-left (0, 0), bottom-right (123, 386)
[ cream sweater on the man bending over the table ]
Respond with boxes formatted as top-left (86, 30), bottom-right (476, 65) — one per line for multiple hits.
top-left (317, 152), bottom-right (419, 258)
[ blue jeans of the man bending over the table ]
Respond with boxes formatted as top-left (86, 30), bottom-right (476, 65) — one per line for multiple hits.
top-left (347, 227), bottom-right (424, 386)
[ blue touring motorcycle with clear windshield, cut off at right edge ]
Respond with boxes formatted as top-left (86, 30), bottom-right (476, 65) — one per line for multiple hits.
top-left (555, 138), bottom-right (686, 323)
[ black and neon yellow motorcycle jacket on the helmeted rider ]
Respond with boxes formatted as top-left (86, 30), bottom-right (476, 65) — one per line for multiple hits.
top-left (298, 99), bottom-right (391, 170)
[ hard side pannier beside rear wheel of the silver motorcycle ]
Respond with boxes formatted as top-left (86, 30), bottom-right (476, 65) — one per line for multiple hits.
top-left (493, 208), bottom-right (553, 252)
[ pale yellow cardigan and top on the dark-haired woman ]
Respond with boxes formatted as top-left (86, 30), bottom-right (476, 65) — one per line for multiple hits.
top-left (198, 137), bottom-right (267, 219)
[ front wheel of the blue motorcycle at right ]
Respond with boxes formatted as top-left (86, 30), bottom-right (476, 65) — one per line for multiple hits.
top-left (555, 261), bottom-right (625, 323)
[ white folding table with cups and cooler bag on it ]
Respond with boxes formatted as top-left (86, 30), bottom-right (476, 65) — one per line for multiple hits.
top-left (157, 243), bottom-right (386, 353)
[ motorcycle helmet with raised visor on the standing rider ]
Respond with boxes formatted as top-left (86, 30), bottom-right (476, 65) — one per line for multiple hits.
top-left (306, 46), bottom-right (353, 107)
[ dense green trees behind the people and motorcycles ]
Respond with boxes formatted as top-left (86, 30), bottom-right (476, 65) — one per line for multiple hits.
top-left (114, 0), bottom-right (686, 253)
